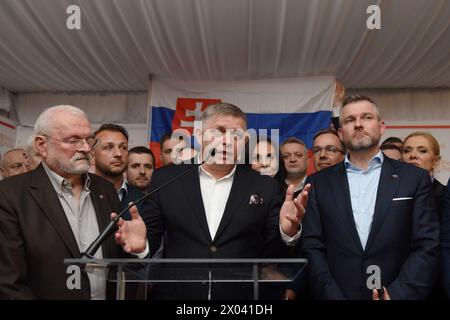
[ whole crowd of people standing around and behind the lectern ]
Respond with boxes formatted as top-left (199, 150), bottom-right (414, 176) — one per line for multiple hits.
top-left (0, 96), bottom-right (450, 300)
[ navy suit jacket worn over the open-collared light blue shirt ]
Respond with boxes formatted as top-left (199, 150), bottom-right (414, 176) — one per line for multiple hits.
top-left (303, 157), bottom-right (439, 299)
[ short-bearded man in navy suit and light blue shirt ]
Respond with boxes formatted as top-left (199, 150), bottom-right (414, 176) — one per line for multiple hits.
top-left (303, 96), bottom-right (439, 299)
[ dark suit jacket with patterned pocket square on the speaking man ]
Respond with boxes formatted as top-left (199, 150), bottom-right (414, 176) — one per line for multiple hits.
top-left (142, 164), bottom-right (287, 299)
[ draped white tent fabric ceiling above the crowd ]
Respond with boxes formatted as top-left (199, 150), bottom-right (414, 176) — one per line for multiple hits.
top-left (0, 0), bottom-right (450, 92)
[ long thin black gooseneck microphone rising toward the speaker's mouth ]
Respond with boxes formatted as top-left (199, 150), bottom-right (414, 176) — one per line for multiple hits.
top-left (81, 148), bottom-right (216, 259)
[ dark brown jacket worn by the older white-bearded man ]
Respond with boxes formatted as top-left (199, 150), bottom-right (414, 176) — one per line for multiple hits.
top-left (0, 165), bottom-right (120, 299)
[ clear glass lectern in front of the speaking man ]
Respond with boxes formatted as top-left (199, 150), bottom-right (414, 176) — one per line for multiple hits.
top-left (64, 258), bottom-right (307, 300)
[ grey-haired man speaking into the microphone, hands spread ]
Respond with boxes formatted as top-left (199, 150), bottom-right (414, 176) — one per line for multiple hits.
top-left (142, 103), bottom-right (309, 299)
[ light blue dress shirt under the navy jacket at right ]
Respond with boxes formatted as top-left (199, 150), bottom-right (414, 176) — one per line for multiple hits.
top-left (344, 151), bottom-right (383, 248)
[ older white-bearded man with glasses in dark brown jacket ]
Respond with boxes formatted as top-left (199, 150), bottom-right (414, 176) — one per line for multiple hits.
top-left (0, 105), bottom-right (146, 299)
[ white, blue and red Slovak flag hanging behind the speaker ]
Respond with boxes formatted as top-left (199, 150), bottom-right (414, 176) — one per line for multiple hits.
top-left (149, 77), bottom-right (336, 167)
